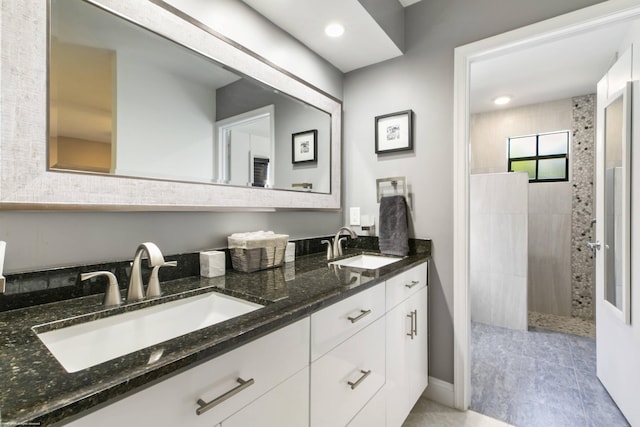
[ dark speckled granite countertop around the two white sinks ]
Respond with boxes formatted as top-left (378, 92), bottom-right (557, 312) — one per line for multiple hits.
top-left (0, 249), bottom-right (429, 425)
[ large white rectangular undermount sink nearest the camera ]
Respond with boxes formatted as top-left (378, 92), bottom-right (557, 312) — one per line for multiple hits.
top-left (34, 292), bottom-right (263, 372)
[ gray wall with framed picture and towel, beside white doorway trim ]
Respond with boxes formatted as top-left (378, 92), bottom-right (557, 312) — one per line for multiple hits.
top-left (343, 0), bottom-right (599, 383)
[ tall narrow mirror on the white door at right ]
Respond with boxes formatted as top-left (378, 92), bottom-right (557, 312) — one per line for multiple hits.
top-left (604, 96), bottom-right (628, 310)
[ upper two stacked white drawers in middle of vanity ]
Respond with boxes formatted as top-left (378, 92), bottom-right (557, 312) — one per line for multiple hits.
top-left (310, 284), bottom-right (385, 427)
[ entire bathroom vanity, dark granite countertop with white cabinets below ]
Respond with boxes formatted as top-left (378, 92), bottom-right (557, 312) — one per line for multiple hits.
top-left (0, 249), bottom-right (430, 427)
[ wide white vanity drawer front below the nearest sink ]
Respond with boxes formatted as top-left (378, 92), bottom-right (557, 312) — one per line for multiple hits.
top-left (70, 318), bottom-right (309, 427)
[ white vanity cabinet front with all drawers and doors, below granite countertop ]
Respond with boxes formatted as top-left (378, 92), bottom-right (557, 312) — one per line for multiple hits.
top-left (61, 262), bottom-right (428, 427)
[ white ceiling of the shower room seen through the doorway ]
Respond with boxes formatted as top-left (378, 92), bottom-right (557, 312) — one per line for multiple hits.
top-left (469, 17), bottom-right (636, 113)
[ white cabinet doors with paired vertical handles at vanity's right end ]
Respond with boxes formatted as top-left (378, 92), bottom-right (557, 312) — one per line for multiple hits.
top-left (385, 288), bottom-right (429, 427)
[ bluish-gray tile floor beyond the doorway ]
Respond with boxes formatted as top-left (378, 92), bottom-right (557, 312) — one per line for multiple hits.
top-left (470, 322), bottom-right (629, 427)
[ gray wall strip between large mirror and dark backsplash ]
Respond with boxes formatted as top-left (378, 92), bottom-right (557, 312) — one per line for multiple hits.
top-left (0, 212), bottom-right (341, 274)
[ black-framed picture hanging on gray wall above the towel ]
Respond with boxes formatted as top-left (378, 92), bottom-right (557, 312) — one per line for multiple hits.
top-left (376, 110), bottom-right (413, 154)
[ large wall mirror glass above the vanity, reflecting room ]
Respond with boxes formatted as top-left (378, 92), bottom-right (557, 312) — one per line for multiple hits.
top-left (48, 0), bottom-right (331, 193)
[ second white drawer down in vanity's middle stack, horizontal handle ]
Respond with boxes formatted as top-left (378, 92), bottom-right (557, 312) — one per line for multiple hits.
top-left (311, 318), bottom-right (385, 427)
